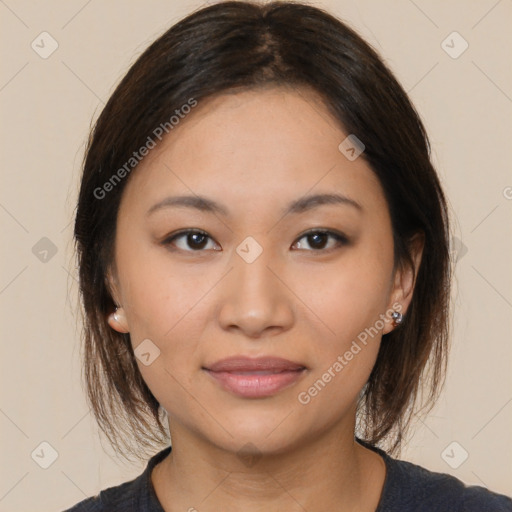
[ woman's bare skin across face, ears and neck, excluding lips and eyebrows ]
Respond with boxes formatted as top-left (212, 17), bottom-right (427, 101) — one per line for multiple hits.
top-left (108, 88), bottom-right (421, 512)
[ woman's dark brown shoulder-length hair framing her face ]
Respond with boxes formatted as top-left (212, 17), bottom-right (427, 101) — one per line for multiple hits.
top-left (74, 1), bottom-right (450, 457)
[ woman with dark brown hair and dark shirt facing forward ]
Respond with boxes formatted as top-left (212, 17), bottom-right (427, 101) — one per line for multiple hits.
top-left (64, 2), bottom-right (512, 512)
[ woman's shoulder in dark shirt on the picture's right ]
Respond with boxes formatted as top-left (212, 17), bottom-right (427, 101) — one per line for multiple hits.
top-left (378, 455), bottom-right (512, 512)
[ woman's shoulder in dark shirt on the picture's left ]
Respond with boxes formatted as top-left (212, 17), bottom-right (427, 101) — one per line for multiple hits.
top-left (64, 446), bottom-right (171, 512)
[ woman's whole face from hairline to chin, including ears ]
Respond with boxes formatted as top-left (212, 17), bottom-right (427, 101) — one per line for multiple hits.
top-left (109, 88), bottom-right (413, 453)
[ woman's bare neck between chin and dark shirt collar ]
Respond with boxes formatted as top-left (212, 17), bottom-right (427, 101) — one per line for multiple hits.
top-left (152, 416), bottom-right (385, 512)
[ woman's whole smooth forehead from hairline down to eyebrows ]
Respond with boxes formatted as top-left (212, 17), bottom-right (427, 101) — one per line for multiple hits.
top-left (118, 88), bottom-right (382, 216)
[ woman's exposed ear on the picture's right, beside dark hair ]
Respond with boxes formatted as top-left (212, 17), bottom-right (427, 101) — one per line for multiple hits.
top-left (383, 233), bottom-right (425, 334)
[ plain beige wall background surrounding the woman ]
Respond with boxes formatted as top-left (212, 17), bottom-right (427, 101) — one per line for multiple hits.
top-left (0, 0), bottom-right (512, 512)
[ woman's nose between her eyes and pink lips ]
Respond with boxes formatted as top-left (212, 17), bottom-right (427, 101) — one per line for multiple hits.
top-left (218, 245), bottom-right (295, 338)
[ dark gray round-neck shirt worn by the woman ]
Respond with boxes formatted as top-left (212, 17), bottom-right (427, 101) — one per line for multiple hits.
top-left (65, 440), bottom-right (512, 512)
